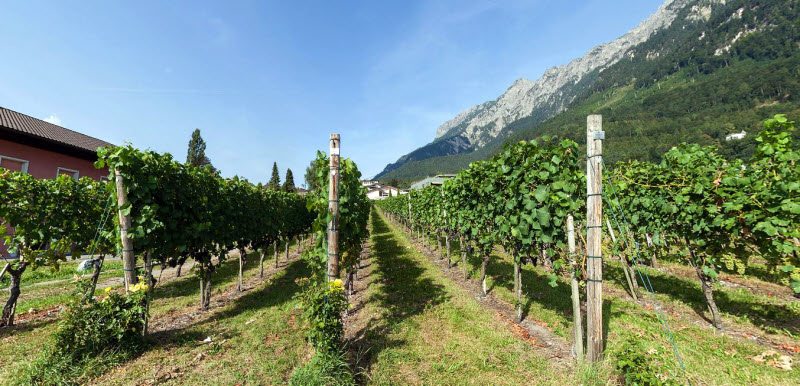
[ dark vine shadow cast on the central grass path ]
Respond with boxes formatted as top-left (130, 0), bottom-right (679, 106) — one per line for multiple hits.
top-left (350, 211), bottom-right (449, 384)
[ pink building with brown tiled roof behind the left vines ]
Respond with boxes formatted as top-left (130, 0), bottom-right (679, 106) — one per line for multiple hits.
top-left (0, 107), bottom-right (111, 255)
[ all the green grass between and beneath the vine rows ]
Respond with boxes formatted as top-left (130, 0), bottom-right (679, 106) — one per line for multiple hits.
top-left (0, 213), bottom-right (800, 385)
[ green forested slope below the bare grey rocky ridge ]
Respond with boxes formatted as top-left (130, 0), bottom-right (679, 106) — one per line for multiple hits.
top-left (378, 0), bottom-right (800, 180)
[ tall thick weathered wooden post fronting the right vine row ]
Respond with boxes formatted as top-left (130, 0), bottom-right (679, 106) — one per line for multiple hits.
top-left (586, 115), bottom-right (605, 362)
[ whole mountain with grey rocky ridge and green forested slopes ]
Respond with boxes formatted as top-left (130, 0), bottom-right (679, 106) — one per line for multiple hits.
top-left (376, 0), bottom-right (800, 180)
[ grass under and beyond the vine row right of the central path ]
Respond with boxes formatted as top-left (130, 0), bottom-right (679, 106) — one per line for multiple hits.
top-left (400, 220), bottom-right (800, 385)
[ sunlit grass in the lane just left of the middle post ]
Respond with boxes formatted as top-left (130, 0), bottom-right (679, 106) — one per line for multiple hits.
top-left (93, 260), bottom-right (310, 385)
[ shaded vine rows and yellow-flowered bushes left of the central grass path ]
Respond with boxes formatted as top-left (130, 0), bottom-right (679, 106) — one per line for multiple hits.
top-left (0, 139), bottom-right (370, 384)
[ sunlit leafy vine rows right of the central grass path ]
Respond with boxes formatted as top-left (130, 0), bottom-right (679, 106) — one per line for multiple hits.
top-left (378, 115), bottom-right (800, 383)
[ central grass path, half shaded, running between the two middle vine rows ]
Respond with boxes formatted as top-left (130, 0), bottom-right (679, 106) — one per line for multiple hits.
top-left (348, 212), bottom-right (584, 385)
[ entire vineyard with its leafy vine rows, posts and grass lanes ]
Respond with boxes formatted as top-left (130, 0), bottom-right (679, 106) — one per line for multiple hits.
top-left (0, 115), bottom-right (800, 385)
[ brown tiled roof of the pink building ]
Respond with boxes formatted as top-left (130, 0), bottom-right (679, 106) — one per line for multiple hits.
top-left (0, 107), bottom-right (111, 152)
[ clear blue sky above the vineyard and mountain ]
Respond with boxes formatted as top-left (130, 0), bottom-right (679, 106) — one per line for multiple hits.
top-left (0, 0), bottom-right (661, 184)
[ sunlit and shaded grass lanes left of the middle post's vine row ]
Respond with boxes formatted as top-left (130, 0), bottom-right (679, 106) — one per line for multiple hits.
top-left (0, 241), bottom-right (310, 385)
